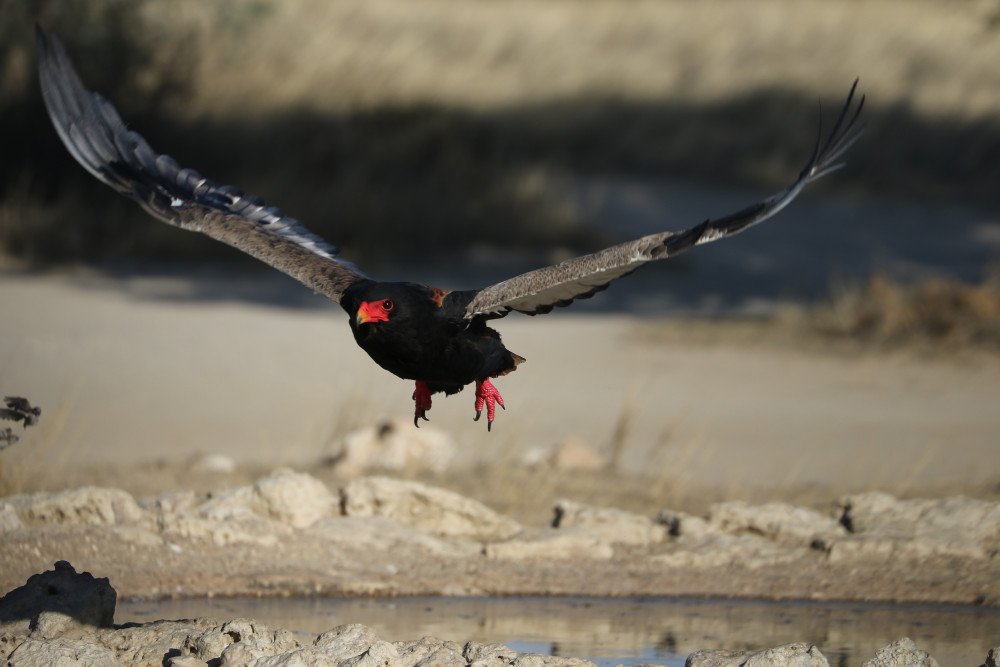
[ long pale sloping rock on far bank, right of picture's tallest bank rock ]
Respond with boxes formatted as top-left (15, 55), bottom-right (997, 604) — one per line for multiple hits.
top-left (341, 477), bottom-right (521, 542)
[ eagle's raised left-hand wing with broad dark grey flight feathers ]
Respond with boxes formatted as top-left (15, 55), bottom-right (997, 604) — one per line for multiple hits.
top-left (36, 28), bottom-right (367, 302)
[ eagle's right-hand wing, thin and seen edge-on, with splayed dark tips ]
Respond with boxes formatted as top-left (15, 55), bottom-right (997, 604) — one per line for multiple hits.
top-left (465, 80), bottom-right (865, 318)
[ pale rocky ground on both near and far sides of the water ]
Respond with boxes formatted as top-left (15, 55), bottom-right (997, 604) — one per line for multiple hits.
top-left (0, 469), bottom-right (1000, 665)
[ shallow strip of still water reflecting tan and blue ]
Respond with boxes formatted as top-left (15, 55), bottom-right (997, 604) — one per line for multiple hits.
top-left (116, 597), bottom-right (1000, 665)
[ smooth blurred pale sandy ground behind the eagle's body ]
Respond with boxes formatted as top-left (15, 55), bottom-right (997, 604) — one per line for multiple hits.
top-left (0, 264), bottom-right (1000, 490)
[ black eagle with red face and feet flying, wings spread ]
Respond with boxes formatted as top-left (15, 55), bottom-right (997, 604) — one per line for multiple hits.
top-left (37, 28), bottom-right (864, 429)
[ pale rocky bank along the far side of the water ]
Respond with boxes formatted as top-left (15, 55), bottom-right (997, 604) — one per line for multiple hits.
top-left (0, 469), bottom-right (1000, 605)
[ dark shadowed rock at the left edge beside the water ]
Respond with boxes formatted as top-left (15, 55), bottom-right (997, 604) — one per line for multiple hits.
top-left (0, 561), bottom-right (118, 627)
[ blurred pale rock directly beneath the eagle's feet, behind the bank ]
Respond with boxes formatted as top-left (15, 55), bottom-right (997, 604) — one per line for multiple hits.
top-left (332, 419), bottom-right (457, 476)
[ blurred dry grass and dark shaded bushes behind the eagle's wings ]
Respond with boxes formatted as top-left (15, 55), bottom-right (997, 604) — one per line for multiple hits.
top-left (0, 0), bottom-right (1000, 263)
